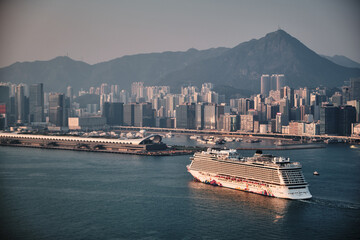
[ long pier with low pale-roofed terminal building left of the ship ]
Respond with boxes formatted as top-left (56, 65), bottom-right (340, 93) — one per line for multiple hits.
top-left (0, 133), bottom-right (198, 156)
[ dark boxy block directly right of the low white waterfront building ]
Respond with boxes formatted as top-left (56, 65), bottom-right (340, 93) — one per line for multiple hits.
top-left (102, 102), bottom-right (124, 126)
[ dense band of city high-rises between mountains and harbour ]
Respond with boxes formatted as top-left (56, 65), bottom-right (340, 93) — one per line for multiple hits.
top-left (0, 74), bottom-right (360, 144)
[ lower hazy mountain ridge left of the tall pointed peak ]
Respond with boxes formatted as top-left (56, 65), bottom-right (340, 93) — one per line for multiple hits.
top-left (0, 48), bottom-right (227, 92)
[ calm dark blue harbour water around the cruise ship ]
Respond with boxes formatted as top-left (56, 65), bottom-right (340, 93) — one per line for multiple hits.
top-left (0, 137), bottom-right (360, 239)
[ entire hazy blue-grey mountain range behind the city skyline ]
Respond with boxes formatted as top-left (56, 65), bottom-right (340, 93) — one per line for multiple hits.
top-left (0, 30), bottom-right (360, 95)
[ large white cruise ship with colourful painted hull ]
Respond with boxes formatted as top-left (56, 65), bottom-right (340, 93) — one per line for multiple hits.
top-left (187, 148), bottom-right (312, 199)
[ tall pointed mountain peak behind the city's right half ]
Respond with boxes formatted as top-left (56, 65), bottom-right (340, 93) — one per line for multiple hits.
top-left (159, 30), bottom-right (360, 92)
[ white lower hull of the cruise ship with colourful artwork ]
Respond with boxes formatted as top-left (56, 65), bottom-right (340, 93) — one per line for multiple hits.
top-left (187, 166), bottom-right (312, 199)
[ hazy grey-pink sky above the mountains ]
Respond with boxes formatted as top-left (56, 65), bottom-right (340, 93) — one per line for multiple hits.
top-left (0, 0), bottom-right (360, 67)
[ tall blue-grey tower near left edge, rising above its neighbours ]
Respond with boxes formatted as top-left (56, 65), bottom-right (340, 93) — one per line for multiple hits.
top-left (29, 83), bottom-right (45, 122)
